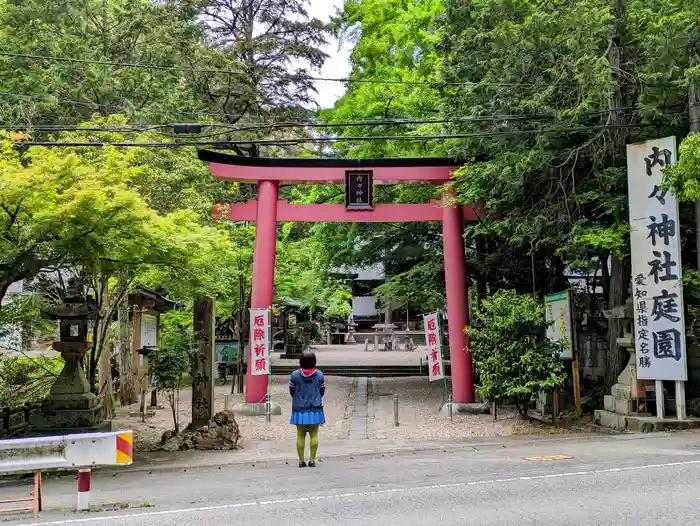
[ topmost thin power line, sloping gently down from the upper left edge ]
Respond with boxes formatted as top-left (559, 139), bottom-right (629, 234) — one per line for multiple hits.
top-left (0, 51), bottom-right (548, 87)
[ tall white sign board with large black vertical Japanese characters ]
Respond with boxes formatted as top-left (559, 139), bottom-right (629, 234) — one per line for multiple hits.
top-left (627, 137), bottom-right (688, 381)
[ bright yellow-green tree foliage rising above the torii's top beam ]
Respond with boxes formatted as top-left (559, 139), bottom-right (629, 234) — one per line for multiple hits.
top-left (322, 0), bottom-right (445, 158)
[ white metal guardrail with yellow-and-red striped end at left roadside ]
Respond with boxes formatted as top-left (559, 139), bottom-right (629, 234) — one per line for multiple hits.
top-left (0, 431), bottom-right (134, 518)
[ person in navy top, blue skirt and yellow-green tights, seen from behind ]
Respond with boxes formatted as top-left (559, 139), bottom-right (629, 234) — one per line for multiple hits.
top-left (289, 351), bottom-right (326, 468)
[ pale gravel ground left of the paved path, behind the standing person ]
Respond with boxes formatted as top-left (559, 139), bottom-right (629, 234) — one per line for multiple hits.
top-left (114, 376), bottom-right (354, 451)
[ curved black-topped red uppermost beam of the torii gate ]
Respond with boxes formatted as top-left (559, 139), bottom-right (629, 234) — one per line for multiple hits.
top-left (198, 150), bottom-right (460, 184)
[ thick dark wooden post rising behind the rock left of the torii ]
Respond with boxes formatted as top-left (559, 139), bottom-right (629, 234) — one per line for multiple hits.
top-left (192, 298), bottom-right (216, 429)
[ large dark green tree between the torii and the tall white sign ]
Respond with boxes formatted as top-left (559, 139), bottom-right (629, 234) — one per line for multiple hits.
top-left (441, 0), bottom-right (688, 384)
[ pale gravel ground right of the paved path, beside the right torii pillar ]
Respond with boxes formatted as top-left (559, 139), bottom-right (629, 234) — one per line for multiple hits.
top-left (367, 377), bottom-right (567, 442)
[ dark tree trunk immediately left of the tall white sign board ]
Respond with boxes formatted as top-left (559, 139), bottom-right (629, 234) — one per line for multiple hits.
top-left (605, 255), bottom-right (631, 388)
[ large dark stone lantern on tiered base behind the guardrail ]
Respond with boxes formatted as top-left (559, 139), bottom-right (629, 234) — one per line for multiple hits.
top-left (30, 279), bottom-right (109, 434)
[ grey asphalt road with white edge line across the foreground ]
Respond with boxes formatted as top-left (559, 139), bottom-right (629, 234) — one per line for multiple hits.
top-left (7, 432), bottom-right (700, 526)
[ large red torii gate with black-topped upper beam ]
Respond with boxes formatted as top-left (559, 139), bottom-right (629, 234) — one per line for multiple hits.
top-left (199, 151), bottom-right (478, 412)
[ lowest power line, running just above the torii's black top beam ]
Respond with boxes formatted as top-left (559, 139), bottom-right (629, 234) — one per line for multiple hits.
top-left (18, 124), bottom-right (668, 148)
